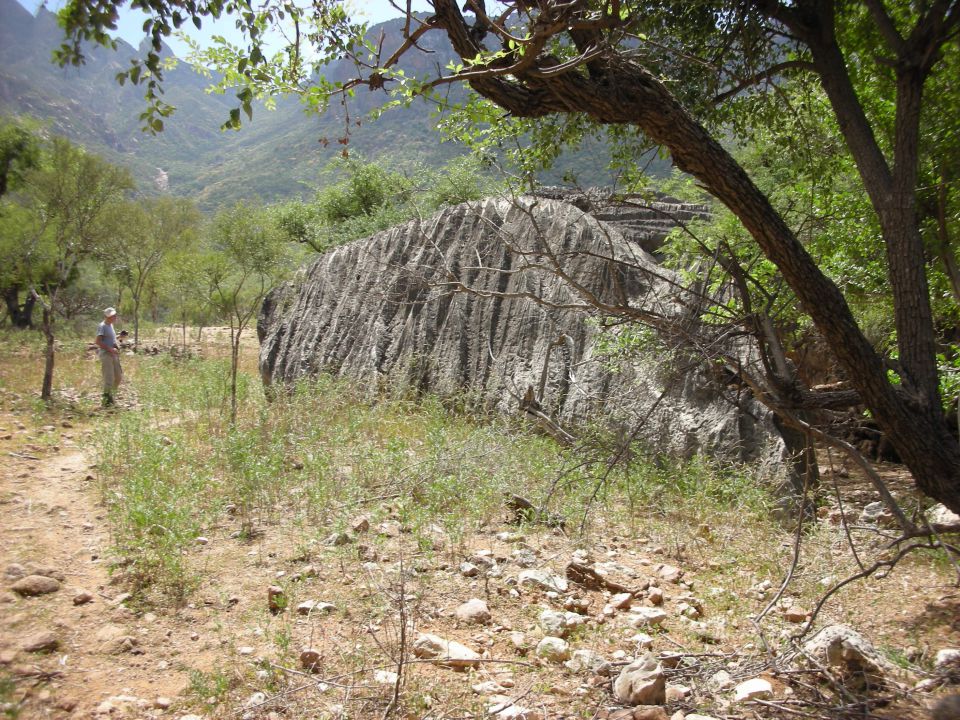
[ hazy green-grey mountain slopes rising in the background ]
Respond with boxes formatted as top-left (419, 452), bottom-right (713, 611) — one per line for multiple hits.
top-left (0, 0), bottom-right (656, 209)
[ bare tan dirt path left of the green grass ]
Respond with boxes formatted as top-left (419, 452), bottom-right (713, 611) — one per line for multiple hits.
top-left (0, 418), bottom-right (197, 718)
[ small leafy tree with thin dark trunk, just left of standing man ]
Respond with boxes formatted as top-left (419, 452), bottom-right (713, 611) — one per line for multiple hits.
top-left (23, 138), bottom-right (133, 400)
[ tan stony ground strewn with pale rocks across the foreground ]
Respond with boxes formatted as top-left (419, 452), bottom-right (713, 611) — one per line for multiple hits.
top-left (0, 346), bottom-right (960, 720)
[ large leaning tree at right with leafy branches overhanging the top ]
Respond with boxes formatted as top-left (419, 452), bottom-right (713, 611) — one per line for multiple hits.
top-left (61, 0), bottom-right (960, 511)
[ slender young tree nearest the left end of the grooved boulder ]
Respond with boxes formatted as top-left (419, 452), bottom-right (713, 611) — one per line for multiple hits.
top-left (200, 203), bottom-right (289, 422)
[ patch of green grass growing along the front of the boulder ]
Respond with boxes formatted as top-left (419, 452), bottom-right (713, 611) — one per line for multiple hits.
top-left (84, 346), bottom-right (788, 602)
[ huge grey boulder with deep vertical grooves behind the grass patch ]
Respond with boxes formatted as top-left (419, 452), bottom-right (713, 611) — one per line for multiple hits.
top-left (258, 197), bottom-right (781, 460)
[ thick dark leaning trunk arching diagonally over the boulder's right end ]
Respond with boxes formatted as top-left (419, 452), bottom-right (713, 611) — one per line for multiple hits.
top-left (434, 0), bottom-right (960, 512)
